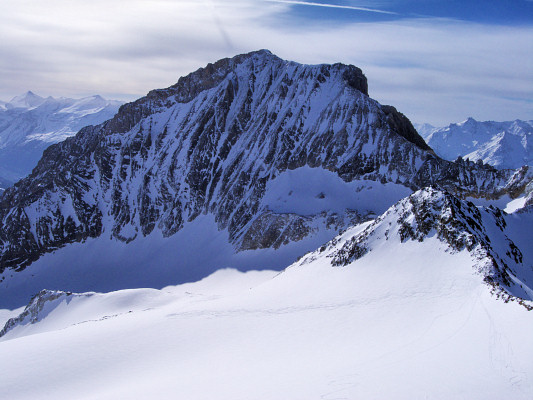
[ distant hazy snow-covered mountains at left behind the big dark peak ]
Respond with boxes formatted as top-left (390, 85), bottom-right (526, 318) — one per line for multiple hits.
top-left (0, 91), bottom-right (122, 188)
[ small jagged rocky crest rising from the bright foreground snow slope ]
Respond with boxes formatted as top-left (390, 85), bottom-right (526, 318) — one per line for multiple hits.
top-left (299, 187), bottom-right (533, 309)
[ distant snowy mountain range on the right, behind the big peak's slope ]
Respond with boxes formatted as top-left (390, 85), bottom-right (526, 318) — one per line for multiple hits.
top-left (416, 118), bottom-right (533, 169)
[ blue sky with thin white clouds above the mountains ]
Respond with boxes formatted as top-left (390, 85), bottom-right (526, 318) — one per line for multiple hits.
top-left (0, 0), bottom-right (533, 126)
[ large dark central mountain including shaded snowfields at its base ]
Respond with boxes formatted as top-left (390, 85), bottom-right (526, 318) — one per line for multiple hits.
top-left (0, 50), bottom-right (533, 305)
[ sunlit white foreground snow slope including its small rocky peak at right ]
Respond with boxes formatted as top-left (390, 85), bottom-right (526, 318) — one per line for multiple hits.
top-left (0, 188), bottom-right (533, 400)
